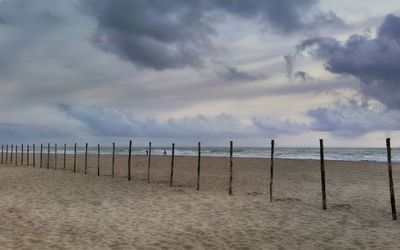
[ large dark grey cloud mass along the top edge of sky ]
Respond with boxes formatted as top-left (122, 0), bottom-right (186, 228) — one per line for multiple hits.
top-left (84, 0), bottom-right (340, 70)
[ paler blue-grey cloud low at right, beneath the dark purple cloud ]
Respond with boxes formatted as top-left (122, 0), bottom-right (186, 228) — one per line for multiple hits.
top-left (307, 100), bottom-right (400, 137)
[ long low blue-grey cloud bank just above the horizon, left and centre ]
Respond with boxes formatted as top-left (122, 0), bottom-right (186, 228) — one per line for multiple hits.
top-left (58, 104), bottom-right (306, 138)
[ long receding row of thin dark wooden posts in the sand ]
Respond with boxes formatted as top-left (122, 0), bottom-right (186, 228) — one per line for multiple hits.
top-left (1, 138), bottom-right (397, 220)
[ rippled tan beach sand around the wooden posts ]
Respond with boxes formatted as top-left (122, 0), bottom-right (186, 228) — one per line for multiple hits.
top-left (0, 155), bottom-right (400, 249)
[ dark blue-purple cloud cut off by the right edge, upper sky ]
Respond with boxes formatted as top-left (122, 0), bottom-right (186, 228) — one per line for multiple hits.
top-left (298, 15), bottom-right (400, 110)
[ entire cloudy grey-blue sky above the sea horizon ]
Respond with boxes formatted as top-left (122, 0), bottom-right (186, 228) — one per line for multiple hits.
top-left (0, 0), bottom-right (400, 147)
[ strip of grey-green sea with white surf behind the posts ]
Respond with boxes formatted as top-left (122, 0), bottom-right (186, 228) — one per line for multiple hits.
top-left (60, 146), bottom-right (400, 162)
